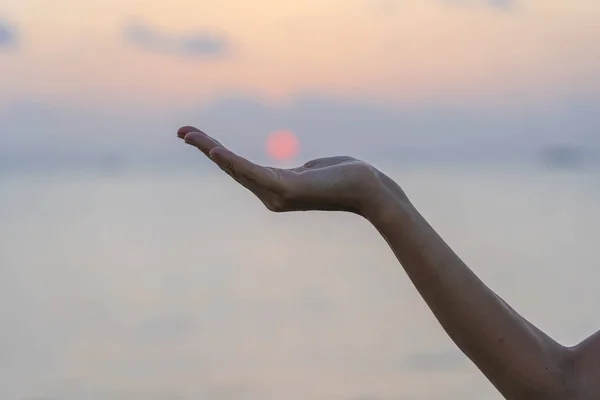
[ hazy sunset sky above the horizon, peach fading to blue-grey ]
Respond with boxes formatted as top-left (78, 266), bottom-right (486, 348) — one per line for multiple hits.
top-left (0, 0), bottom-right (600, 159)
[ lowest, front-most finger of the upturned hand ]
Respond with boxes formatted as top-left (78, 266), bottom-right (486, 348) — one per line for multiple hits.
top-left (208, 147), bottom-right (283, 193)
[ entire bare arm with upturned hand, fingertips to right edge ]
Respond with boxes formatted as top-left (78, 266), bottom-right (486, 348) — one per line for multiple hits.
top-left (177, 126), bottom-right (600, 400)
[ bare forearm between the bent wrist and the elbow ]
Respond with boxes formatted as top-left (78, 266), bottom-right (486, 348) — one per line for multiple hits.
top-left (366, 182), bottom-right (568, 399)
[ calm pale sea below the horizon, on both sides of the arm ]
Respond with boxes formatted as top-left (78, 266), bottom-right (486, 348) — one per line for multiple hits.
top-left (0, 165), bottom-right (600, 400)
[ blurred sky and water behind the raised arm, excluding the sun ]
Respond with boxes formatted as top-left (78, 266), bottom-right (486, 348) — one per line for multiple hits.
top-left (0, 0), bottom-right (600, 400)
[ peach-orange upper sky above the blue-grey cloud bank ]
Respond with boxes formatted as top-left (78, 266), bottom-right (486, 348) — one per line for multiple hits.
top-left (0, 0), bottom-right (600, 161)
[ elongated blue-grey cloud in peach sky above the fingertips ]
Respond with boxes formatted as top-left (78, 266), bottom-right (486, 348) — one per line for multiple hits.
top-left (123, 22), bottom-right (230, 59)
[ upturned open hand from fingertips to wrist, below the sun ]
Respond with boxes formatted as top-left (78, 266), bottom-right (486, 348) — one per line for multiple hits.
top-left (177, 126), bottom-right (389, 215)
